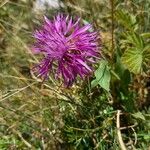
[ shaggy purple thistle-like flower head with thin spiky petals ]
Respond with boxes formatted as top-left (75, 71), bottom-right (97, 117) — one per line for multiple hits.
top-left (33, 14), bottom-right (99, 87)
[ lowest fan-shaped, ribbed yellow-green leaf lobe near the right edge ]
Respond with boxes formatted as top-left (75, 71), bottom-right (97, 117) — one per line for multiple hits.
top-left (121, 48), bottom-right (143, 74)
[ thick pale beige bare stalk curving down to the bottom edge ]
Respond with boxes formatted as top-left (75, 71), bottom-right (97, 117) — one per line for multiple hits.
top-left (116, 110), bottom-right (127, 150)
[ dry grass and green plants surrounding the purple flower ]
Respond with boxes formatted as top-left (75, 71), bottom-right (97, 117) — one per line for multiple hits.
top-left (0, 0), bottom-right (150, 150)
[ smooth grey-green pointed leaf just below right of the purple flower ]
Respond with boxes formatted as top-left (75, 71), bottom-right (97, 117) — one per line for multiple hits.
top-left (91, 60), bottom-right (111, 91)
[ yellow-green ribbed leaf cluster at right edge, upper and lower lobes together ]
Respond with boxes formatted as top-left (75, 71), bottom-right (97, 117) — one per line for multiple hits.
top-left (122, 32), bottom-right (150, 74)
